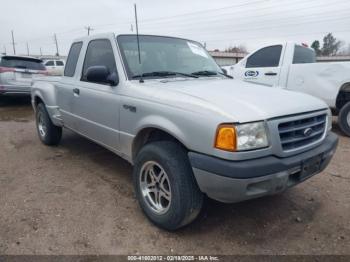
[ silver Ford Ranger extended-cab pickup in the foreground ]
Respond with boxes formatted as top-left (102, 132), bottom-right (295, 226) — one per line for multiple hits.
top-left (32, 34), bottom-right (338, 230)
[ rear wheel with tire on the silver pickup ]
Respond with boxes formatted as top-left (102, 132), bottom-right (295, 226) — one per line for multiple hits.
top-left (35, 103), bottom-right (62, 146)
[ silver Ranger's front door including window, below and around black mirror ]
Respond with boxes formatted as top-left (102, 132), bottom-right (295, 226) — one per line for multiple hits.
top-left (72, 39), bottom-right (120, 150)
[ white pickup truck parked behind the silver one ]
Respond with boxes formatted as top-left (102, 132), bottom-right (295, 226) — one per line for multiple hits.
top-left (224, 42), bottom-right (350, 136)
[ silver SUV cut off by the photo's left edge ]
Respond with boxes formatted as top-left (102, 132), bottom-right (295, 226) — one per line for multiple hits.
top-left (0, 55), bottom-right (47, 96)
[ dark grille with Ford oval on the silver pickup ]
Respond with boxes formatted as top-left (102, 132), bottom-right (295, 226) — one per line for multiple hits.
top-left (278, 114), bottom-right (327, 151)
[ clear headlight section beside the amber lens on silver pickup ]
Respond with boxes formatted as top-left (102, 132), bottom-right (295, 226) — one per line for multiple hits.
top-left (235, 122), bottom-right (269, 151)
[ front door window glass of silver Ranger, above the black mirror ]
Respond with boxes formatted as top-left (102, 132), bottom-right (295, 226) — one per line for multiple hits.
top-left (81, 39), bottom-right (117, 81)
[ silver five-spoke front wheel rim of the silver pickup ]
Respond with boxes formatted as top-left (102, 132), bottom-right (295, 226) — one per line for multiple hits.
top-left (139, 161), bottom-right (172, 215)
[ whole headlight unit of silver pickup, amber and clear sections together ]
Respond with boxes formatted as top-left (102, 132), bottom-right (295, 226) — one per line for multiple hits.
top-left (215, 122), bottom-right (269, 151)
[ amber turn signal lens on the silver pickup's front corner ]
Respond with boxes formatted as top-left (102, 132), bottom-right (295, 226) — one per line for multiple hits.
top-left (214, 124), bottom-right (237, 151)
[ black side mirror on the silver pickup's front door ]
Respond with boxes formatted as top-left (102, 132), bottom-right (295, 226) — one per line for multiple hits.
top-left (86, 66), bottom-right (119, 86)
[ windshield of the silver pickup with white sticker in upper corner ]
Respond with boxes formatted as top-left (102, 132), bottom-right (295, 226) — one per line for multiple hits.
top-left (117, 35), bottom-right (222, 79)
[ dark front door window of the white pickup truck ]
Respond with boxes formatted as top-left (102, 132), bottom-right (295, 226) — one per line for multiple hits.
top-left (246, 45), bottom-right (282, 68)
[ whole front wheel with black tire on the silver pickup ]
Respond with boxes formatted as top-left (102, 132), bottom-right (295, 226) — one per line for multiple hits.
top-left (133, 141), bottom-right (203, 230)
